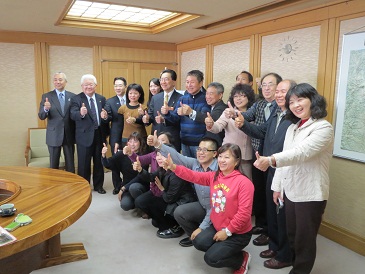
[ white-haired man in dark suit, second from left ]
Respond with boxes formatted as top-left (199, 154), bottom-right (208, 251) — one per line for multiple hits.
top-left (70, 74), bottom-right (109, 194)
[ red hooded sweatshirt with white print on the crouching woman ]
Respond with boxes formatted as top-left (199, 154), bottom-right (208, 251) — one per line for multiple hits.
top-left (175, 166), bottom-right (254, 234)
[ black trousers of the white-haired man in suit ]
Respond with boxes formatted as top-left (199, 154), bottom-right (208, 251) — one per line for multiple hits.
top-left (77, 129), bottom-right (104, 190)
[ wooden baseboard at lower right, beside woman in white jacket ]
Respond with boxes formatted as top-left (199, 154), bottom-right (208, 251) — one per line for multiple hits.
top-left (319, 221), bottom-right (365, 256)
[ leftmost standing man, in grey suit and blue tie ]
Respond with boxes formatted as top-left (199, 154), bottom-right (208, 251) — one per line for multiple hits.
top-left (38, 72), bottom-right (75, 173)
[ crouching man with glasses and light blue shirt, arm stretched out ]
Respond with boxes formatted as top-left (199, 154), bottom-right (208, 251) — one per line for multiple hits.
top-left (147, 133), bottom-right (218, 247)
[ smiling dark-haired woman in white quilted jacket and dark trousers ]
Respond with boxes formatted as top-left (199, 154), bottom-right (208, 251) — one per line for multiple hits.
top-left (255, 83), bottom-right (333, 274)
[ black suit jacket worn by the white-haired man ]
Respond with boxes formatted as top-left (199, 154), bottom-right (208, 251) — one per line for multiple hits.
top-left (70, 92), bottom-right (109, 147)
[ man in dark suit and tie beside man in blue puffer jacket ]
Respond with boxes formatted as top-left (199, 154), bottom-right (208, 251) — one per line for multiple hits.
top-left (143, 69), bottom-right (182, 151)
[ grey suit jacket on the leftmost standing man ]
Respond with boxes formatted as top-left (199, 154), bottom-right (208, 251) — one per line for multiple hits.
top-left (38, 90), bottom-right (75, 147)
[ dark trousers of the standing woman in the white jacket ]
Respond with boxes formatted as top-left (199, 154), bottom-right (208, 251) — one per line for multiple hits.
top-left (285, 197), bottom-right (327, 274)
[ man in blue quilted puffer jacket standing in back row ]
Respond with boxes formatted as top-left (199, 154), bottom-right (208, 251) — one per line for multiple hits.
top-left (161, 70), bottom-right (210, 157)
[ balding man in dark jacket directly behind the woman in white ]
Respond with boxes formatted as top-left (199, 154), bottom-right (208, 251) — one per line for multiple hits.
top-left (235, 80), bottom-right (296, 269)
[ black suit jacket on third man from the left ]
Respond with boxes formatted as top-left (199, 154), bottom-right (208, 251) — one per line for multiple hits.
top-left (102, 95), bottom-right (124, 147)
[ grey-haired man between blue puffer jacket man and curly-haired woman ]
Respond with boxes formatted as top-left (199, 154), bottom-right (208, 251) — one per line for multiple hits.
top-left (195, 82), bottom-right (228, 147)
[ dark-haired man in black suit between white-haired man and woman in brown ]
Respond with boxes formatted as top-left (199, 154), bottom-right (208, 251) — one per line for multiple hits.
top-left (101, 77), bottom-right (127, 195)
